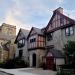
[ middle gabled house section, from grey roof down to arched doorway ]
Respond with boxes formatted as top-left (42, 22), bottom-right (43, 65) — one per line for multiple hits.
top-left (28, 27), bottom-right (45, 67)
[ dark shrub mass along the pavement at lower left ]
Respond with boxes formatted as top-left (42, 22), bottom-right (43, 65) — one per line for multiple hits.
top-left (0, 58), bottom-right (29, 69)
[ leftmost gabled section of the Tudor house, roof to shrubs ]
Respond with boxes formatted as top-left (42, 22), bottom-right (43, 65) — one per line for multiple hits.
top-left (15, 28), bottom-right (29, 62)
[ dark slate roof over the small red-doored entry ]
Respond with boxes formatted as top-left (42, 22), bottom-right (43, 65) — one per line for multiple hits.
top-left (46, 49), bottom-right (64, 58)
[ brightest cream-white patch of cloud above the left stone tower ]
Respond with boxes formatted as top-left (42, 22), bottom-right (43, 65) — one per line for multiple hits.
top-left (5, 10), bottom-right (30, 33)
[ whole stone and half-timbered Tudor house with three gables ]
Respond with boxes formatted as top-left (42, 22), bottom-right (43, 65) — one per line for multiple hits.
top-left (15, 7), bottom-right (75, 69)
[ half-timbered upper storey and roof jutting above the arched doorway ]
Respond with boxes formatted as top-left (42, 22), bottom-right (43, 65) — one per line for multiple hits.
top-left (28, 27), bottom-right (45, 49)
